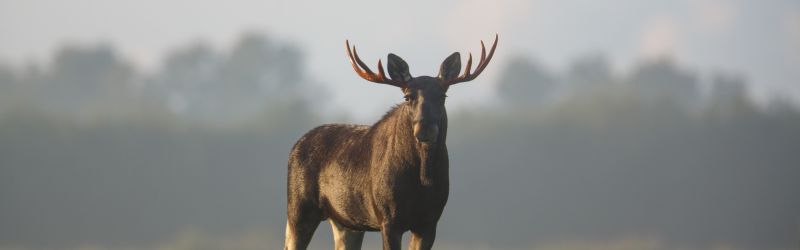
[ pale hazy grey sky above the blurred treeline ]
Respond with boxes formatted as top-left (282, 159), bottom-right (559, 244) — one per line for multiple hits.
top-left (0, 0), bottom-right (800, 121)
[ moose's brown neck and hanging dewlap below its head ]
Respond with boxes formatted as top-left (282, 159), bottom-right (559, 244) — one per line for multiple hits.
top-left (373, 105), bottom-right (448, 186)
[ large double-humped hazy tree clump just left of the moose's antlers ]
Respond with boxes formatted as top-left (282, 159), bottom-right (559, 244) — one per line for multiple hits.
top-left (149, 33), bottom-right (324, 127)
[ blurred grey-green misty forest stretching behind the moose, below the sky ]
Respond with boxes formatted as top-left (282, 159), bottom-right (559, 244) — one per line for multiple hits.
top-left (0, 33), bottom-right (800, 249)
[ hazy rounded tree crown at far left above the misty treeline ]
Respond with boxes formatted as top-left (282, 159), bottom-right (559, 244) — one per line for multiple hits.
top-left (30, 45), bottom-right (140, 119)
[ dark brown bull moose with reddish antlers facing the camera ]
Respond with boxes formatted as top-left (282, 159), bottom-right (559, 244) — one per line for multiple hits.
top-left (284, 35), bottom-right (498, 250)
